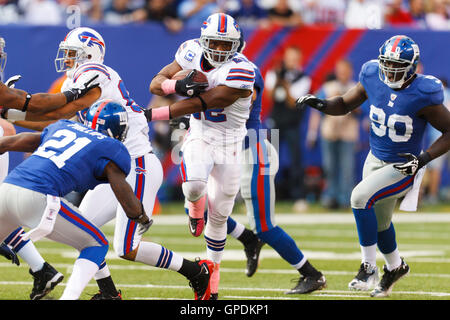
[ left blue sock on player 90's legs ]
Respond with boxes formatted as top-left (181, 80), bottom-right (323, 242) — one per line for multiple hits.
top-left (352, 208), bottom-right (378, 247)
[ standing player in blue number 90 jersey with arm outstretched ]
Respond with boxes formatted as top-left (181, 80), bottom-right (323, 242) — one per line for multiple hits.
top-left (297, 35), bottom-right (450, 297)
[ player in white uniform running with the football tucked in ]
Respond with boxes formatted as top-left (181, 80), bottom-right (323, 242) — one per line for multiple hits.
top-left (149, 13), bottom-right (255, 297)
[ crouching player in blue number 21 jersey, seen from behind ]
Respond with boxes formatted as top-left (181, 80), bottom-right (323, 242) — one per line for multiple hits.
top-left (0, 100), bottom-right (151, 300)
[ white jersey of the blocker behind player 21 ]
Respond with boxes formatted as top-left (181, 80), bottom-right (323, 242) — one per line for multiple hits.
top-left (61, 63), bottom-right (152, 159)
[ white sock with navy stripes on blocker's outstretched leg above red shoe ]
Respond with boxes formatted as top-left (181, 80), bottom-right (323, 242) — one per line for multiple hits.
top-left (135, 241), bottom-right (183, 271)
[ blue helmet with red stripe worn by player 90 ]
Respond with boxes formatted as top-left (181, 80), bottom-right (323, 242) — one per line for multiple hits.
top-left (378, 35), bottom-right (420, 89)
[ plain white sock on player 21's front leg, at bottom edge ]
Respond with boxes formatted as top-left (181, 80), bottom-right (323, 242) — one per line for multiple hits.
top-left (59, 258), bottom-right (98, 300)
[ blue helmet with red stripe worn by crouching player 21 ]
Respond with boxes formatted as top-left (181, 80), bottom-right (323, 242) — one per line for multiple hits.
top-left (84, 99), bottom-right (128, 142)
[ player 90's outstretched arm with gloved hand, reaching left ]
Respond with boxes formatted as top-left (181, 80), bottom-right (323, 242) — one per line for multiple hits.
top-left (296, 82), bottom-right (367, 116)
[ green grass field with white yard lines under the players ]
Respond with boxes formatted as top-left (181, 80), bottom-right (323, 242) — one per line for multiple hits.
top-left (0, 203), bottom-right (450, 300)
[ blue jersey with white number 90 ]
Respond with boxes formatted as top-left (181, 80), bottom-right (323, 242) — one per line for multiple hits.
top-left (359, 60), bottom-right (444, 162)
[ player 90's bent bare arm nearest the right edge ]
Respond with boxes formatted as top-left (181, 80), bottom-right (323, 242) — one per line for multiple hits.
top-left (419, 104), bottom-right (450, 161)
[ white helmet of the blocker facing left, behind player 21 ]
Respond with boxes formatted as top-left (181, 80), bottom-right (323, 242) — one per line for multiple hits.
top-left (55, 27), bottom-right (106, 72)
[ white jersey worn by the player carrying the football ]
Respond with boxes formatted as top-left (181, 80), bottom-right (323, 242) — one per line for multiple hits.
top-left (175, 39), bottom-right (255, 145)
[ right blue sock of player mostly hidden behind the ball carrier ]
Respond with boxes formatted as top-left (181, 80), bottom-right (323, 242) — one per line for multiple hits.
top-left (258, 226), bottom-right (304, 265)
